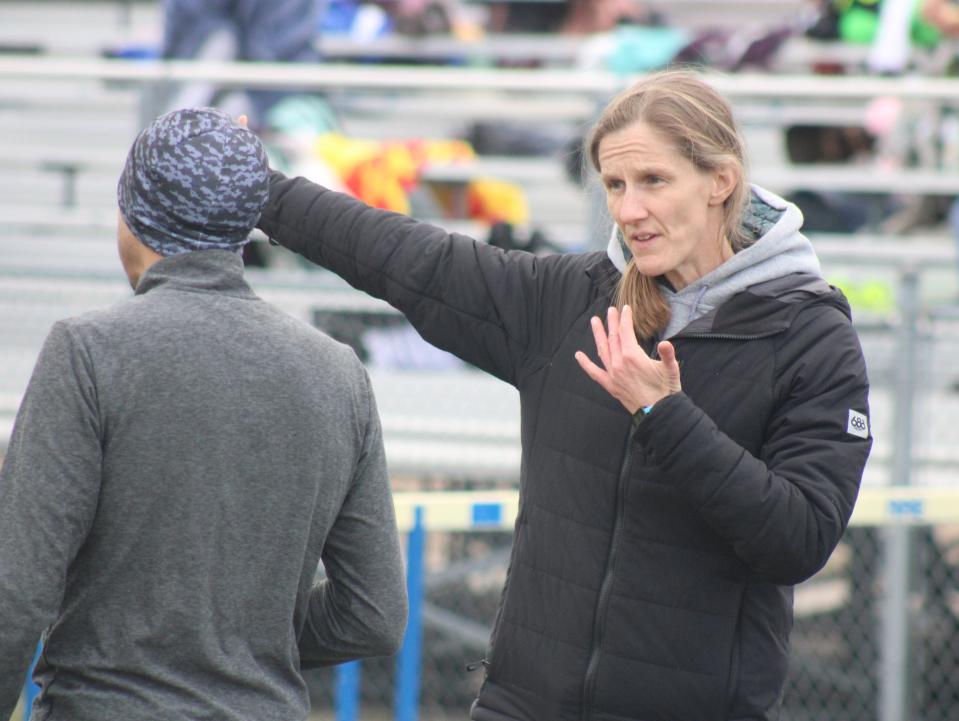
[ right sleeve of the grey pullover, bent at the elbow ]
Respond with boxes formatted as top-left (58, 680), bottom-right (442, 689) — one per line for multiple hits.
top-left (299, 375), bottom-right (407, 668)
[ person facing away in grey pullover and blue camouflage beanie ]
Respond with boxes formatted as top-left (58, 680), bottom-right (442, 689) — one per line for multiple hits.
top-left (0, 109), bottom-right (407, 721)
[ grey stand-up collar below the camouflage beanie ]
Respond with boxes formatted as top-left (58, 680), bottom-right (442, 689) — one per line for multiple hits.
top-left (136, 250), bottom-right (256, 299)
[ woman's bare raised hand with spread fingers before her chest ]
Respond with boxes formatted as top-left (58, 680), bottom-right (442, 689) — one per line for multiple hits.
top-left (575, 305), bottom-right (682, 413)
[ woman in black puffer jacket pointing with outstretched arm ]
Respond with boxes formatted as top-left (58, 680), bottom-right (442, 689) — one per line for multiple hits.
top-left (253, 72), bottom-right (872, 721)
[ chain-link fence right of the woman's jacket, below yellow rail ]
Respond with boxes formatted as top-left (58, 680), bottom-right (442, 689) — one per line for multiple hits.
top-left (783, 526), bottom-right (959, 721)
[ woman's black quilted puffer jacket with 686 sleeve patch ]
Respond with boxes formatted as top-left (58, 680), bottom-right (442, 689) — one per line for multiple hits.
top-left (260, 175), bottom-right (871, 721)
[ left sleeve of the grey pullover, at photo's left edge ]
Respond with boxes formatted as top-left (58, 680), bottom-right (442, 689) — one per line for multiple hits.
top-left (0, 322), bottom-right (101, 719)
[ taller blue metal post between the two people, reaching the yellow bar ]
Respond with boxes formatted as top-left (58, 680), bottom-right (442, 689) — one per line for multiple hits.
top-left (396, 506), bottom-right (426, 721)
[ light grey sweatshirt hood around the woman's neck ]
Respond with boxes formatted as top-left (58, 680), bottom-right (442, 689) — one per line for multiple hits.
top-left (606, 185), bottom-right (822, 338)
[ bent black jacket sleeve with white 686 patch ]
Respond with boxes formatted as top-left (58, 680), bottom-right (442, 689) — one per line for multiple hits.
top-left (637, 308), bottom-right (872, 585)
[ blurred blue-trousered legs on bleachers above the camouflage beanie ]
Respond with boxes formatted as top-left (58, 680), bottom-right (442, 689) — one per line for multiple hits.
top-left (160, 0), bottom-right (326, 131)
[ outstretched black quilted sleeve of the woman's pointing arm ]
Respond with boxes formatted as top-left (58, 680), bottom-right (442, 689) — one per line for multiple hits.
top-left (257, 173), bottom-right (587, 385)
